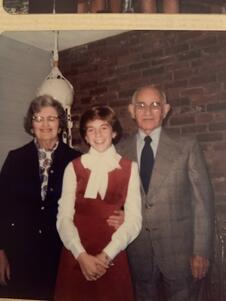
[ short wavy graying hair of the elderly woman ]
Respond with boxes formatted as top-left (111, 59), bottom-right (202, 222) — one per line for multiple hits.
top-left (24, 95), bottom-right (67, 136)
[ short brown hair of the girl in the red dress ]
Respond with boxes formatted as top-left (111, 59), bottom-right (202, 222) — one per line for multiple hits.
top-left (79, 105), bottom-right (122, 144)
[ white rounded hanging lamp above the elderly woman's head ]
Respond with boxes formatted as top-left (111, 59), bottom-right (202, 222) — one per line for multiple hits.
top-left (37, 66), bottom-right (74, 108)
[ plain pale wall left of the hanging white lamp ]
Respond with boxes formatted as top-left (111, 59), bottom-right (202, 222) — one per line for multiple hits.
top-left (0, 33), bottom-right (50, 168)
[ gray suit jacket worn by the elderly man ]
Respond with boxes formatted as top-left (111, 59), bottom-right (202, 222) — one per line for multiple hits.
top-left (117, 130), bottom-right (214, 280)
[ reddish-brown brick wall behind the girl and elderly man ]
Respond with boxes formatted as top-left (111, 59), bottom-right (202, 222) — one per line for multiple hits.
top-left (60, 31), bottom-right (226, 301)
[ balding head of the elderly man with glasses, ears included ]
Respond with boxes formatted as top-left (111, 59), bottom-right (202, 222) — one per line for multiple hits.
top-left (129, 87), bottom-right (170, 135)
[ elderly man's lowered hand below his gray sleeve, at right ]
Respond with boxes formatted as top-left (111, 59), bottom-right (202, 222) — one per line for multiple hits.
top-left (191, 256), bottom-right (209, 280)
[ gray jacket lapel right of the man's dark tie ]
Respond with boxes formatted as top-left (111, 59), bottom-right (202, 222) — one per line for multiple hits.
top-left (148, 130), bottom-right (181, 200)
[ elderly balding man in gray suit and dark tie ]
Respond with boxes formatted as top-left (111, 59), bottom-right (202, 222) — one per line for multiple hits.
top-left (116, 86), bottom-right (213, 301)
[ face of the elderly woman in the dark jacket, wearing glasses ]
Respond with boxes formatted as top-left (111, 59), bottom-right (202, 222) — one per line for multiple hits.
top-left (32, 107), bottom-right (60, 146)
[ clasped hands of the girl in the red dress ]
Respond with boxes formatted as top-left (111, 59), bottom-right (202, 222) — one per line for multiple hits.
top-left (77, 252), bottom-right (108, 281)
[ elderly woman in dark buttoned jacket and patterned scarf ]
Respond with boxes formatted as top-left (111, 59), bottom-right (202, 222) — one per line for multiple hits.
top-left (0, 95), bottom-right (80, 300)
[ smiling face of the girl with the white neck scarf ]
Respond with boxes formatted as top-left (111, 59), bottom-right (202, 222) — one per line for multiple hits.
top-left (85, 119), bottom-right (116, 152)
